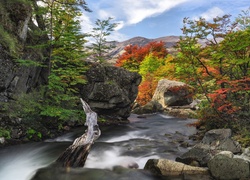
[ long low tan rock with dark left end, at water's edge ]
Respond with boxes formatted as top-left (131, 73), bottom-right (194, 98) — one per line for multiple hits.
top-left (144, 159), bottom-right (209, 176)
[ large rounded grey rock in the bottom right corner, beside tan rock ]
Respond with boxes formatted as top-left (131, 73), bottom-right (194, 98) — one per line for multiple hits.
top-left (208, 151), bottom-right (250, 180)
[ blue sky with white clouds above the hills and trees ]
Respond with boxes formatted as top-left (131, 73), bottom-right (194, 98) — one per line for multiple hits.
top-left (82, 0), bottom-right (250, 41)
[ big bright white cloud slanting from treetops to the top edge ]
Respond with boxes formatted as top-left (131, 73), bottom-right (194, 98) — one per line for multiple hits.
top-left (82, 0), bottom-right (193, 41)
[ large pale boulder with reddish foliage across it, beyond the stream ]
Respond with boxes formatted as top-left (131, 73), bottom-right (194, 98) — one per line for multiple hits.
top-left (152, 79), bottom-right (194, 108)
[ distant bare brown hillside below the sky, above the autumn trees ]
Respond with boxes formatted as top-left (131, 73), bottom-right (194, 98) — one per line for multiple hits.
top-left (105, 36), bottom-right (179, 63)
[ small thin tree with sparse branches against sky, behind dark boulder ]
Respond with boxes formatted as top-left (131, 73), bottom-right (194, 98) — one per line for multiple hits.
top-left (90, 17), bottom-right (118, 62)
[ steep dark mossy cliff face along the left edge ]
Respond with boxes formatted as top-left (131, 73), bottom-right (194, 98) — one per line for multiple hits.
top-left (0, 1), bottom-right (48, 102)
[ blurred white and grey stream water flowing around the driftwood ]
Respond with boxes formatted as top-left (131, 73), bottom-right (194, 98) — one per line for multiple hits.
top-left (0, 114), bottom-right (196, 180)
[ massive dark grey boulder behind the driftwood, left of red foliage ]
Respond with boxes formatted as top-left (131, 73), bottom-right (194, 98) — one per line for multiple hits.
top-left (81, 65), bottom-right (141, 120)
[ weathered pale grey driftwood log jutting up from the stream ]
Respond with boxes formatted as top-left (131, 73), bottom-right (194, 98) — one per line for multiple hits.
top-left (56, 98), bottom-right (101, 167)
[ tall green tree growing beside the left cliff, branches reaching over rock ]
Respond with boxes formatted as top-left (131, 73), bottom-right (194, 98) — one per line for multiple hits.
top-left (5, 0), bottom-right (91, 120)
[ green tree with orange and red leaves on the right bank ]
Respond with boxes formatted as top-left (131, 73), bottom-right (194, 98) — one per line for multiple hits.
top-left (175, 9), bottom-right (250, 136)
